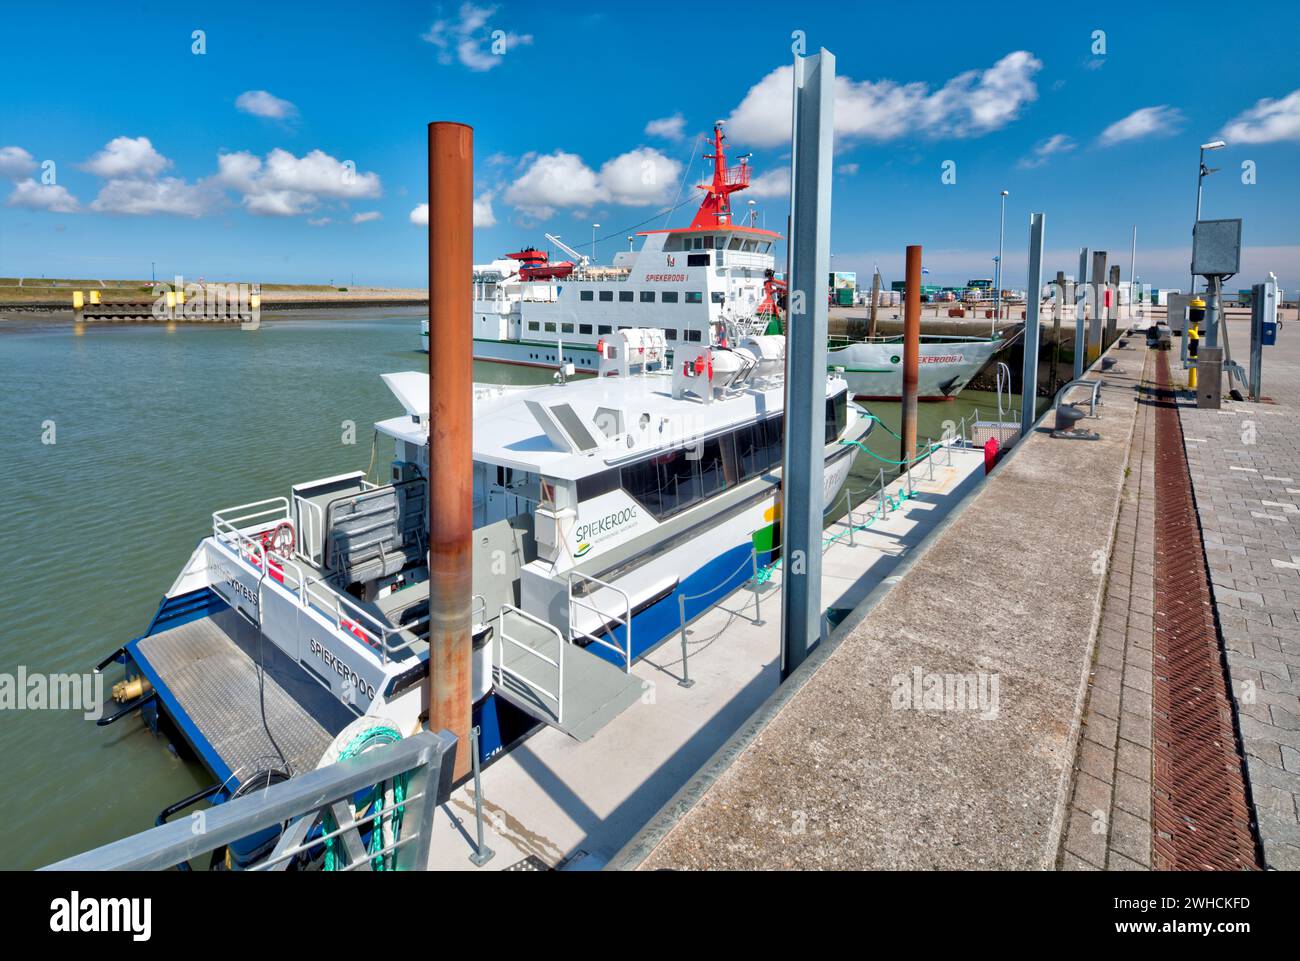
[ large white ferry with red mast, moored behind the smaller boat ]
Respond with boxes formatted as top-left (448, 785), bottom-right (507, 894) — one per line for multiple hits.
top-left (420, 121), bottom-right (1004, 401)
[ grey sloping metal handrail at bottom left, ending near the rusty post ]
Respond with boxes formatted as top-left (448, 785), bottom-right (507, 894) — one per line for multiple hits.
top-left (42, 731), bottom-right (456, 871)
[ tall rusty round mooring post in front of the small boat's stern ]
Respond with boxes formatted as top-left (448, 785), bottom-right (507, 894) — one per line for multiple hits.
top-left (429, 124), bottom-right (475, 780)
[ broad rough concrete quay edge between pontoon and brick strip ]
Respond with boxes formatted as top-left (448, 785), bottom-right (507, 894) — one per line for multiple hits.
top-left (616, 349), bottom-right (1149, 869)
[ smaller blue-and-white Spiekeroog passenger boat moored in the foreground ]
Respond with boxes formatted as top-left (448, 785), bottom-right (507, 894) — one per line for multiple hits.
top-left (99, 323), bottom-right (874, 866)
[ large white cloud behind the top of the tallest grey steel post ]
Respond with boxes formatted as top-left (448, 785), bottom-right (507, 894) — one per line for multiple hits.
top-left (729, 51), bottom-right (1043, 147)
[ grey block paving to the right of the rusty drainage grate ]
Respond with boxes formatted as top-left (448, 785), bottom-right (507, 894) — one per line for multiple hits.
top-left (1182, 315), bottom-right (1300, 870)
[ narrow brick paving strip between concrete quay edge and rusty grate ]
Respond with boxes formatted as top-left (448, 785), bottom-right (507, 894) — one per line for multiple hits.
top-left (1060, 349), bottom-right (1156, 871)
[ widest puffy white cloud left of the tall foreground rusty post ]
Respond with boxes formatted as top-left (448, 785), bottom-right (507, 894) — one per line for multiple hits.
top-left (216, 147), bottom-right (382, 217)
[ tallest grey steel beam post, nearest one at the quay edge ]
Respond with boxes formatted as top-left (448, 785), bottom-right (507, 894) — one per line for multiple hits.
top-left (781, 49), bottom-right (835, 680)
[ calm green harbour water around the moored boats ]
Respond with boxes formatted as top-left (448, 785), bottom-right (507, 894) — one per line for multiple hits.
top-left (0, 308), bottom-right (1013, 867)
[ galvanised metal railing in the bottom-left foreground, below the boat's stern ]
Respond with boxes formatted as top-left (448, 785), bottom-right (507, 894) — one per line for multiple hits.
top-left (43, 731), bottom-right (456, 871)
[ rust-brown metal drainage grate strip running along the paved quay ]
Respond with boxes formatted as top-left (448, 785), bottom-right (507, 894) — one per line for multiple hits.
top-left (1152, 351), bottom-right (1260, 871)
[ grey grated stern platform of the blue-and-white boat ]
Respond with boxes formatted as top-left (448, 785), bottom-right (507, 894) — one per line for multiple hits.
top-left (133, 612), bottom-right (332, 782)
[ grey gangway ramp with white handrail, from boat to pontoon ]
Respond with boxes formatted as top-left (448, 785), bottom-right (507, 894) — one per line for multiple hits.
top-left (493, 605), bottom-right (642, 741)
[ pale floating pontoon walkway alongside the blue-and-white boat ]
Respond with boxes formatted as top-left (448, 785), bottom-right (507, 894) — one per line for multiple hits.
top-left (430, 449), bottom-right (983, 870)
